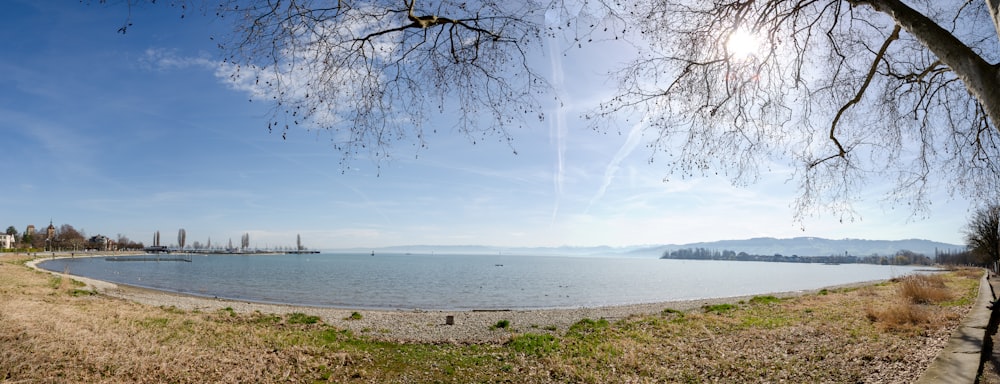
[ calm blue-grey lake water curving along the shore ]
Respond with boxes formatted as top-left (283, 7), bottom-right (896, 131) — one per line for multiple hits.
top-left (40, 254), bottom-right (918, 310)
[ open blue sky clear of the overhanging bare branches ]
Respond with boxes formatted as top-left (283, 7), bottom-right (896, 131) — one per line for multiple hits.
top-left (0, 0), bottom-right (969, 249)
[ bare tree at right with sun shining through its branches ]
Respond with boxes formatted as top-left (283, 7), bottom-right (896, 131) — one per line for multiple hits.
top-left (593, 0), bottom-right (1000, 219)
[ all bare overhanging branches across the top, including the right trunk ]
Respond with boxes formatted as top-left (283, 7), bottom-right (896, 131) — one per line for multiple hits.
top-left (101, 0), bottom-right (1000, 219)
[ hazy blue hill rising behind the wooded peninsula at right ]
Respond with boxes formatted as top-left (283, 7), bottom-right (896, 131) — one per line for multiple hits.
top-left (635, 237), bottom-right (965, 257)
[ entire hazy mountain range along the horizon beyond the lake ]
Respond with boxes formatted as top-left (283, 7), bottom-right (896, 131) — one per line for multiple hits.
top-left (332, 237), bottom-right (965, 257)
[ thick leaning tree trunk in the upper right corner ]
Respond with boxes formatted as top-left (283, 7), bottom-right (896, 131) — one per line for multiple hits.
top-left (849, 0), bottom-right (1000, 129)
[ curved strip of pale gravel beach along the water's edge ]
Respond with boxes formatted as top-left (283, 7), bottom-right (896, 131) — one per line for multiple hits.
top-left (27, 254), bottom-right (875, 343)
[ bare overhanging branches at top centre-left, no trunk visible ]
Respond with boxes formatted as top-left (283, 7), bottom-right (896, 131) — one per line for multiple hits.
top-left (211, 0), bottom-right (560, 168)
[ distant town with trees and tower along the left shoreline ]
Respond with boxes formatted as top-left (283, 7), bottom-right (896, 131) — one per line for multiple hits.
top-left (0, 221), bottom-right (319, 254)
